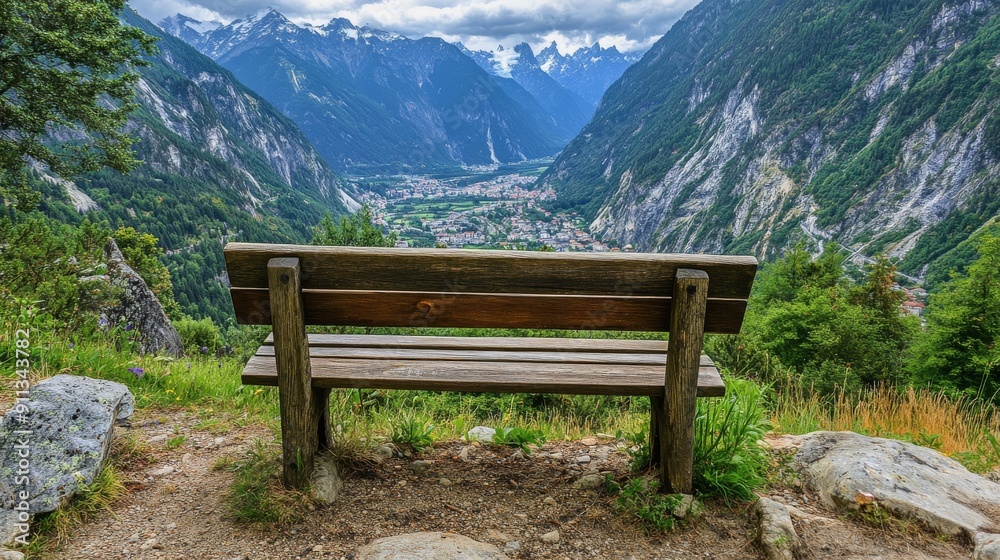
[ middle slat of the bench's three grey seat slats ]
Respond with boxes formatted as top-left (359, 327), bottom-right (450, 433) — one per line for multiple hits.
top-left (257, 345), bottom-right (713, 366)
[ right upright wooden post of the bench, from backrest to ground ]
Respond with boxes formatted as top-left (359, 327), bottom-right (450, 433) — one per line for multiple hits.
top-left (657, 269), bottom-right (709, 494)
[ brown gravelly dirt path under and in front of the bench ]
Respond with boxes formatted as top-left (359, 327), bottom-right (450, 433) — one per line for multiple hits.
top-left (45, 413), bottom-right (969, 560)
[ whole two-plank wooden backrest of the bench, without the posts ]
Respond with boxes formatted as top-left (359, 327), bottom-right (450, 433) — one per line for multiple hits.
top-left (225, 243), bottom-right (757, 333)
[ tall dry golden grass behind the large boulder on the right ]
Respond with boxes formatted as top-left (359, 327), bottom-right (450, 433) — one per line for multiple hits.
top-left (771, 386), bottom-right (1000, 472)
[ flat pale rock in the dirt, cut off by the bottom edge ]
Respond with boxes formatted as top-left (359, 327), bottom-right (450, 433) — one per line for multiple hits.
top-left (354, 533), bottom-right (508, 560)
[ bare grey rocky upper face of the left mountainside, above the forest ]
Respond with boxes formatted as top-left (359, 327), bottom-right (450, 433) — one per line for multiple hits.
top-left (127, 9), bottom-right (338, 211)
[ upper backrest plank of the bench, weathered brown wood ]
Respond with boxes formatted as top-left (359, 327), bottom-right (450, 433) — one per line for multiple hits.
top-left (225, 243), bottom-right (757, 299)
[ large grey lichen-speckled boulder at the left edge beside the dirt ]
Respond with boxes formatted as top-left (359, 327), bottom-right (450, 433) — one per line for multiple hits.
top-left (0, 375), bottom-right (134, 545)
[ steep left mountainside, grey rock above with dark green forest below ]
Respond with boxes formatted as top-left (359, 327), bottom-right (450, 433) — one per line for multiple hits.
top-left (36, 9), bottom-right (355, 324)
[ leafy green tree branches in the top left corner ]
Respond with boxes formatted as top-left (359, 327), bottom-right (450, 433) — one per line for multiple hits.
top-left (0, 0), bottom-right (156, 208)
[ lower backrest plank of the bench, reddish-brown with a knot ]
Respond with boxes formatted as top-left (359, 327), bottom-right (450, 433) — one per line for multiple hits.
top-left (230, 288), bottom-right (746, 334)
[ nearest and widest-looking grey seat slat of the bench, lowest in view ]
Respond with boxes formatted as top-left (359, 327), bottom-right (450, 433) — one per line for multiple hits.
top-left (243, 356), bottom-right (725, 397)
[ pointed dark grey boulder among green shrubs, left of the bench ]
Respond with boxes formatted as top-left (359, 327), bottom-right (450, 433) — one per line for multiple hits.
top-left (104, 239), bottom-right (184, 356)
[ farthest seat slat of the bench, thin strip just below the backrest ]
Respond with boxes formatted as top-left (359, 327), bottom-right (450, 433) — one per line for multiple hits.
top-left (264, 334), bottom-right (667, 355)
